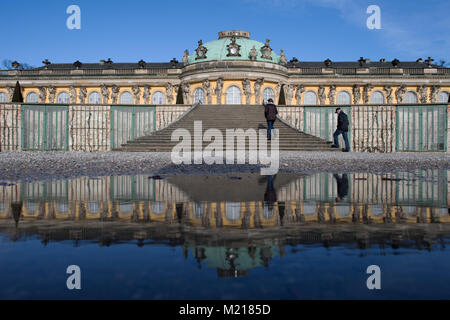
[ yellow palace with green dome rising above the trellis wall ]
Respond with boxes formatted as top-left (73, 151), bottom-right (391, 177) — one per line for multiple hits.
top-left (0, 30), bottom-right (450, 105)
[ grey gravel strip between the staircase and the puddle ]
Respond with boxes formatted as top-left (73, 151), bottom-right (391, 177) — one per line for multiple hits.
top-left (0, 151), bottom-right (450, 182)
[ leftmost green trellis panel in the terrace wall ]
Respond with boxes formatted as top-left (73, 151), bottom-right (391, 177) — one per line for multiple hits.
top-left (21, 105), bottom-right (69, 151)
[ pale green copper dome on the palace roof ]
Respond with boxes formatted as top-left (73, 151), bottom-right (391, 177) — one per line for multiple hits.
top-left (187, 31), bottom-right (280, 65)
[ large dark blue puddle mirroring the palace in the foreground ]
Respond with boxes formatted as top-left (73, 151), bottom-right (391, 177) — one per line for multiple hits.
top-left (0, 170), bottom-right (450, 299)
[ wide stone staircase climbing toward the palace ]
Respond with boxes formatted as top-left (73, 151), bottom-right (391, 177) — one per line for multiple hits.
top-left (115, 105), bottom-right (336, 152)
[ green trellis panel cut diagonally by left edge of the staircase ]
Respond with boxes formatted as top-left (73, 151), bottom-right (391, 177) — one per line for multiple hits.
top-left (110, 106), bottom-right (156, 149)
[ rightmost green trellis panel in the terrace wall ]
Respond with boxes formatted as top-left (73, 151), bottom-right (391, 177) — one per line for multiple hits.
top-left (396, 105), bottom-right (447, 152)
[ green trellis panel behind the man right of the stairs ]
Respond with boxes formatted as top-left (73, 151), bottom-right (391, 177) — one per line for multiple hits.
top-left (303, 107), bottom-right (351, 146)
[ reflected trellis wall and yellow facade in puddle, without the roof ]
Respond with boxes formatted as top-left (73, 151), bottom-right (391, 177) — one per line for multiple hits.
top-left (0, 171), bottom-right (450, 228)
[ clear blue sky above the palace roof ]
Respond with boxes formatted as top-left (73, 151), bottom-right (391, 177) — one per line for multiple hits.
top-left (0, 0), bottom-right (450, 66)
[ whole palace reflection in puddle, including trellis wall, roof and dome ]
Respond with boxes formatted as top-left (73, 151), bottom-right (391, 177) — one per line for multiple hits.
top-left (0, 171), bottom-right (450, 276)
